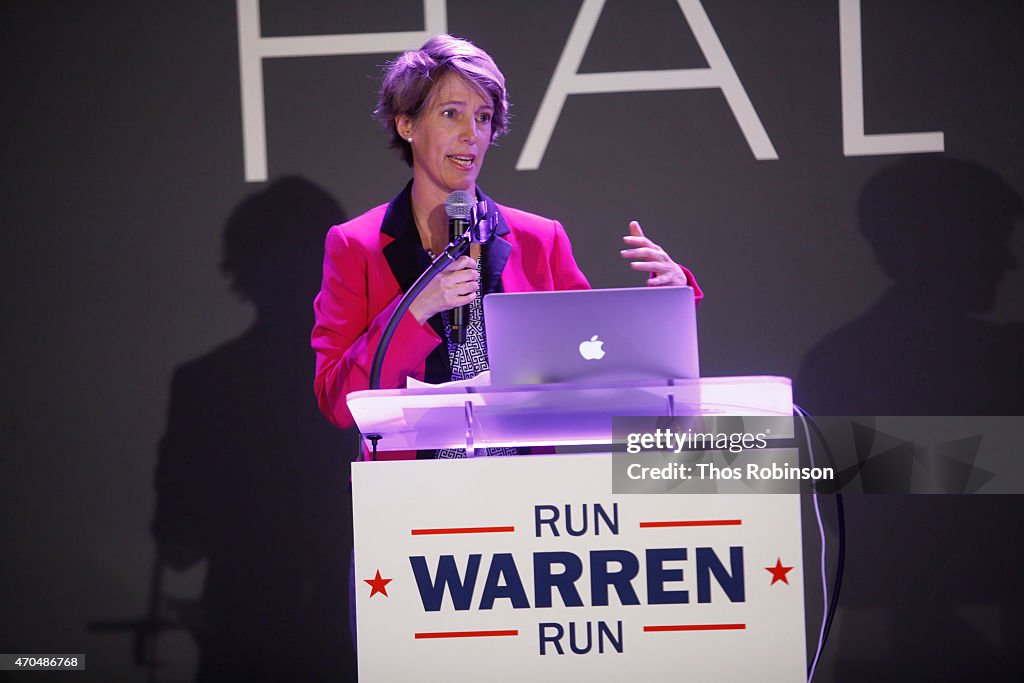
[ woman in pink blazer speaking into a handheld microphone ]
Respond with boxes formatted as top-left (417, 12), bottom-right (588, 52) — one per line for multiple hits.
top-left (312, 35), bottom-right (700, 448)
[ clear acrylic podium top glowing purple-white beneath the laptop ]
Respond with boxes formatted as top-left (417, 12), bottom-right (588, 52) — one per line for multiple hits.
top-left (347, 376), bottom-right (793, 451)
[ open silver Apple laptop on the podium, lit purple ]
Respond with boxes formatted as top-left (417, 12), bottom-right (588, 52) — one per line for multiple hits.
top-left (483, 287), bottom-right (700, 385)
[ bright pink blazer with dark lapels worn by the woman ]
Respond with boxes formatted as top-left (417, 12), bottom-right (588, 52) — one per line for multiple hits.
top-left (311, 184), bottom-right (700, 459)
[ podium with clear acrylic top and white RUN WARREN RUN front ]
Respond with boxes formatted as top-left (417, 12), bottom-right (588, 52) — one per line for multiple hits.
top-left (348, 377), bottom-right (806, 682)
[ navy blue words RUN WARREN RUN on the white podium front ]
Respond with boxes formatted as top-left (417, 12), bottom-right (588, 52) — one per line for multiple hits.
top-left (409, 503), bottom-right (746, 654)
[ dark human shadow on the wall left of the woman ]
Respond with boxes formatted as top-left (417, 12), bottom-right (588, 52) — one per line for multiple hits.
top-left (153, 177), bottom-right (355, 681)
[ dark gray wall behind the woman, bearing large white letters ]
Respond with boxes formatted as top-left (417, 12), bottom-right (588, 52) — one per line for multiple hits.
top-left (0, 0), bottom-right (1024, 681)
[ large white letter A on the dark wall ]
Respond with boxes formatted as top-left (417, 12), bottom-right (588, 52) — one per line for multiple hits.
top-left (515, 0), bottom-right (778, 171)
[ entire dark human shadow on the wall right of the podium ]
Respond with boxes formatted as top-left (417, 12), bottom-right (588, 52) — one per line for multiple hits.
top-left (794, 156), bottom-right (1024, 681)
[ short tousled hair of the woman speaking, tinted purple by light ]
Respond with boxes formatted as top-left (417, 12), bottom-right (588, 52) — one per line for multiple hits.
top-left (374, 34), bottom-right (509, 166)
